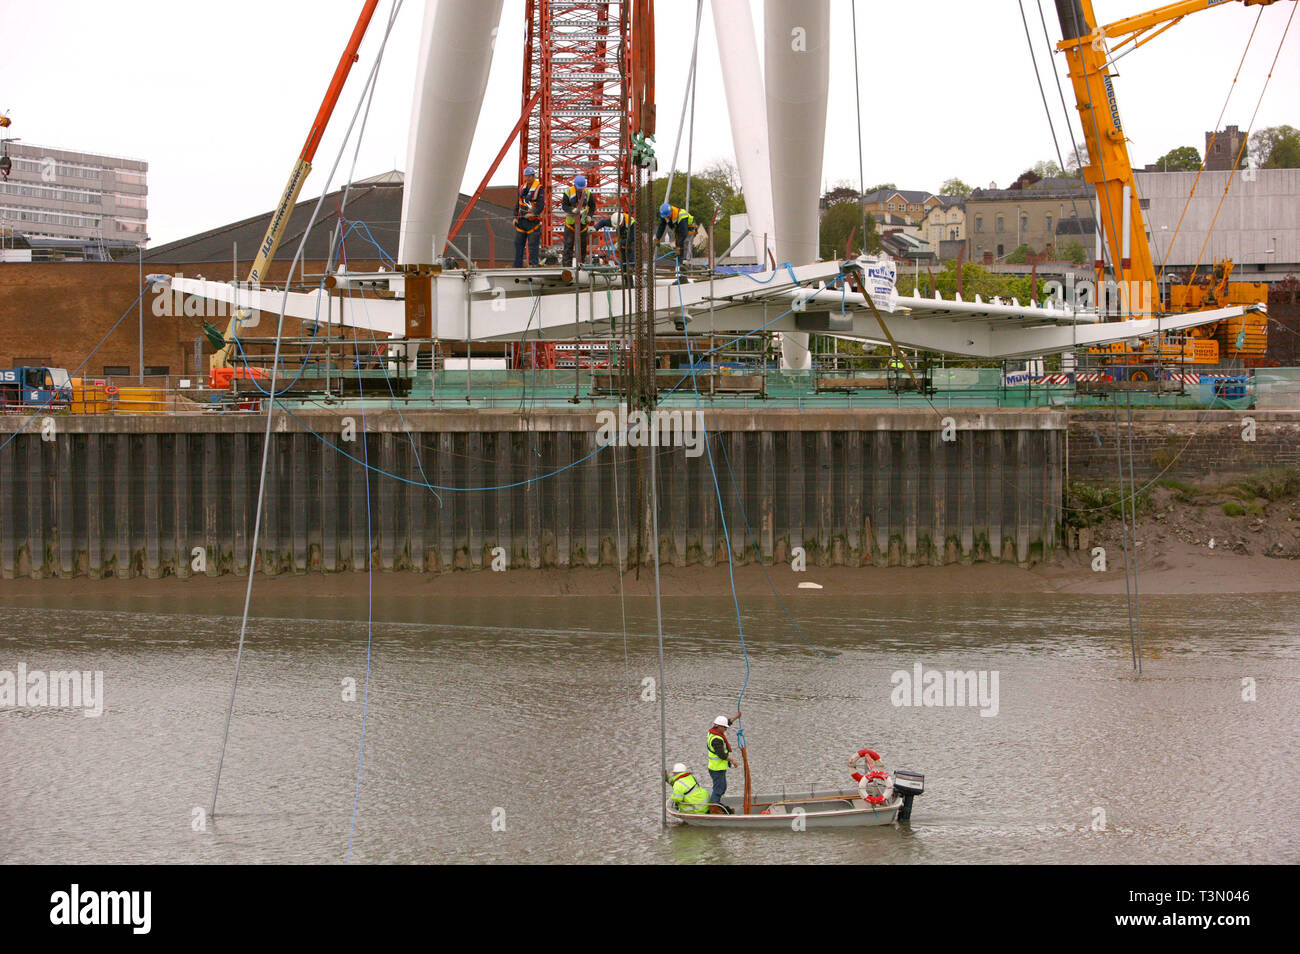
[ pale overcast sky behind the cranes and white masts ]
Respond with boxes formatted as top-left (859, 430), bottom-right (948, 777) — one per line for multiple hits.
top-left (0, 0), bottom-right (1300, 244)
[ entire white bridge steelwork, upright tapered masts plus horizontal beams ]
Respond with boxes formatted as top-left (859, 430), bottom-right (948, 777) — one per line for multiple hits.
top-left (151, 0), bottom-right (1260, 368)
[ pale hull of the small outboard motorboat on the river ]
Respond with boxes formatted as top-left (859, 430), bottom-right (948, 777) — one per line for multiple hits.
top-left (668, 788), bottom-right (902, 831)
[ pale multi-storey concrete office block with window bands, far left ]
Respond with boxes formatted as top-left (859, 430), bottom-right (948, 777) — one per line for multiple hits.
top-left (0, 142), bottom-right (150, 260)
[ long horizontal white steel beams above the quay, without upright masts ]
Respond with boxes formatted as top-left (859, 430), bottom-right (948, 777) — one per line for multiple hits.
top-left (151, 257), bottom-right (1247, 360)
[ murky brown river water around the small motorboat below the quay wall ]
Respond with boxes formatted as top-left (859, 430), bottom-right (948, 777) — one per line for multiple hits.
top-left (0, 590), bottom-right (1300, 864)
